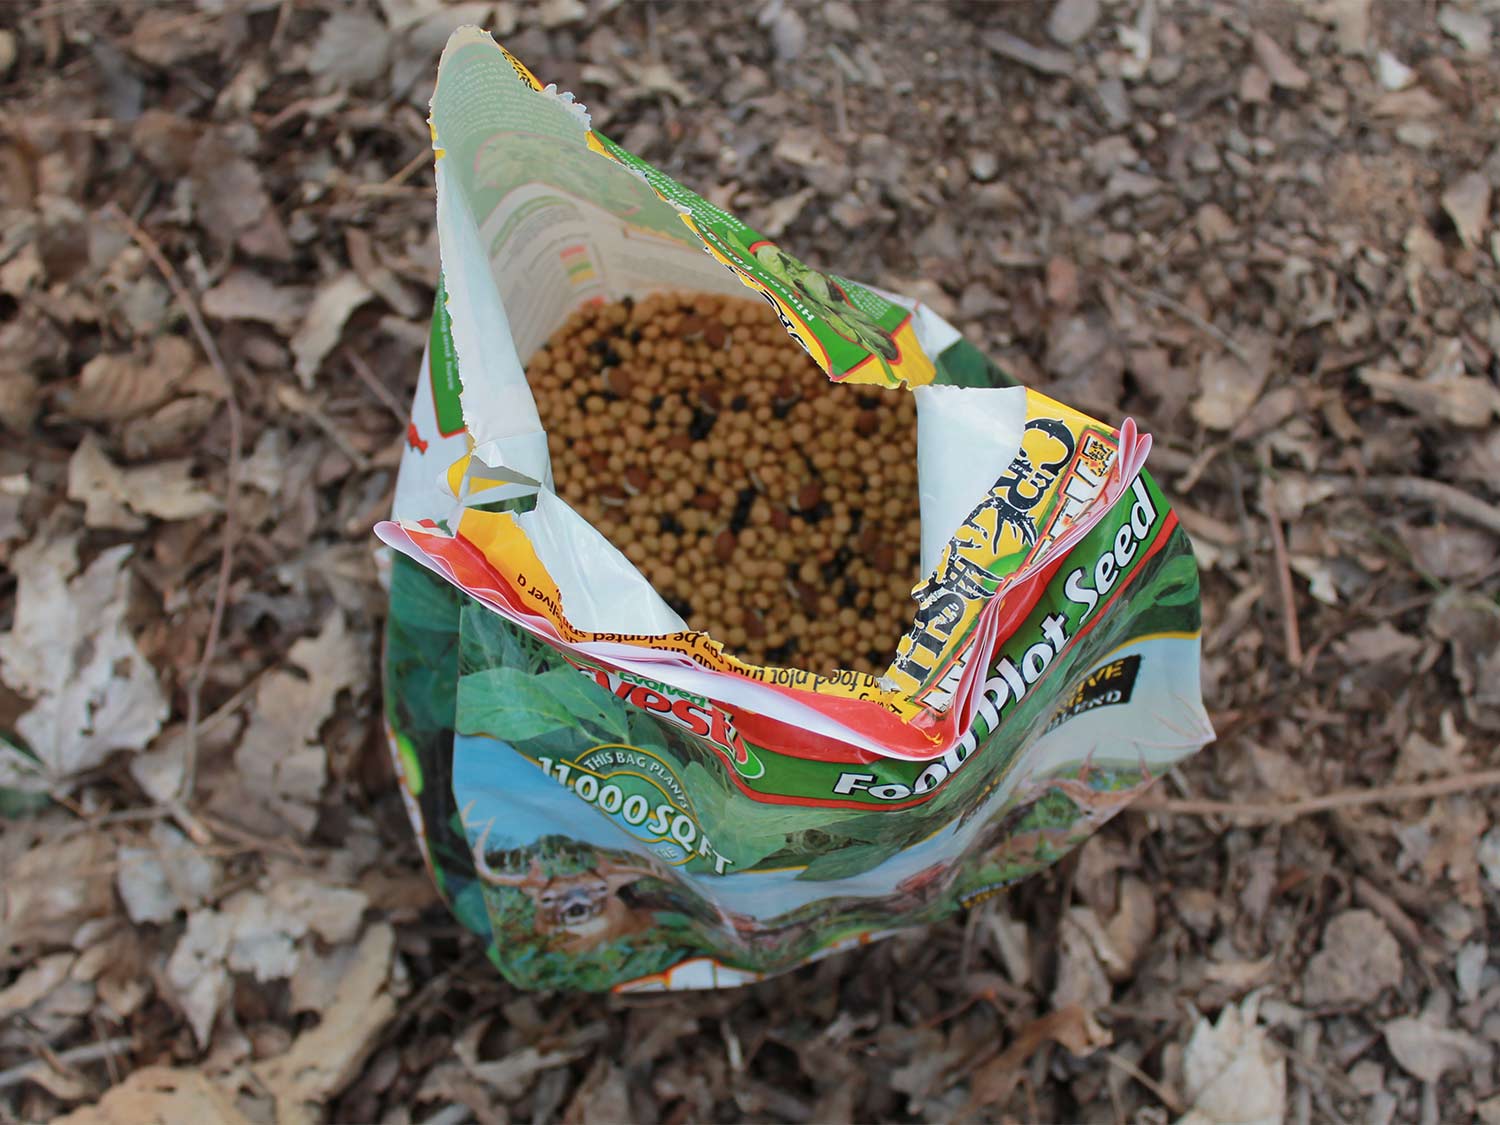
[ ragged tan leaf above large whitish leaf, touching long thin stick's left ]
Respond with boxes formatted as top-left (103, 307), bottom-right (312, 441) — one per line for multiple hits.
top-left (68, 434), bottom-right (222, 531)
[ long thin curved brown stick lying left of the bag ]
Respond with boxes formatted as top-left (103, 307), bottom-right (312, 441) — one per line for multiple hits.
top-left (107, 203), bottom-right (245, 807)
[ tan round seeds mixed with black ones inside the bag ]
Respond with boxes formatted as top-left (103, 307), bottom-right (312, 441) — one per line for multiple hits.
top-left (527, 294), bottom-right (920, 674)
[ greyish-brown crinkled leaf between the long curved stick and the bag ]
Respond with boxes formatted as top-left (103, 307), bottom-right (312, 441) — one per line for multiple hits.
top-left (228, 611), bottom-right (365, 836)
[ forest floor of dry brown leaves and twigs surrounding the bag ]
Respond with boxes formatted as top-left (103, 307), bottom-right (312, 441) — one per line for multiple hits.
top-left (0, 0), bottom-right (1500, 1125)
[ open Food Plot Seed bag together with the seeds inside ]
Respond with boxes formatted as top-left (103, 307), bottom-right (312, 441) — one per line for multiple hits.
top-left (378, 29), bottom-right (1212, 990)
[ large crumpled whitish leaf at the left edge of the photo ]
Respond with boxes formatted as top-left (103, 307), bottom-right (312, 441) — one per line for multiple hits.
top-left (0, 534), bottom-right (168, 791)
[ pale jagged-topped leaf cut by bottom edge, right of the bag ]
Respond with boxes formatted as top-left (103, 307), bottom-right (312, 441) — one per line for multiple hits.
top-left (1178, 996), bottom-right (1287, 1125)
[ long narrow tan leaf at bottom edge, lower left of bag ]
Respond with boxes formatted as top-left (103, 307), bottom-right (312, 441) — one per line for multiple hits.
top-left (254, 924), bottom-right (396, 1125)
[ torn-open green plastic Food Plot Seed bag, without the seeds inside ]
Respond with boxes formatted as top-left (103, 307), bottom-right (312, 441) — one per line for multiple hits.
top-left (378, 29), bottom-right (1212, 990)
